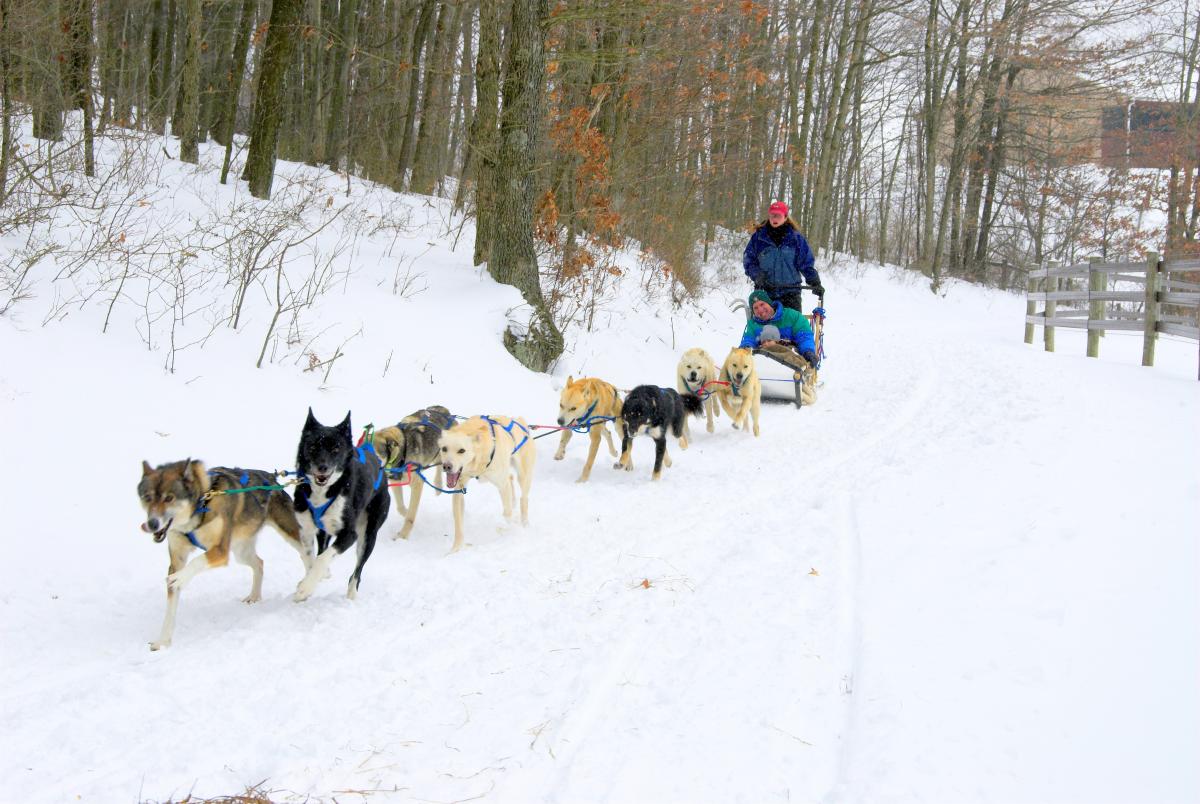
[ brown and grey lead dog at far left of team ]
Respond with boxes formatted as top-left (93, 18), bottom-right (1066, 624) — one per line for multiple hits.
top-left (138, 458), bottom-right (313, 650)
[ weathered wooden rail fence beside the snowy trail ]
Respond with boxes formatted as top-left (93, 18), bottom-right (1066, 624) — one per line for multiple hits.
top-left (1025, 253), bottom-right (1200, 379)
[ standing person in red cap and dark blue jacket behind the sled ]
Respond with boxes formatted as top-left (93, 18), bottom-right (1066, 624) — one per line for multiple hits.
top-left (742, 202), bottom-right (824, 312)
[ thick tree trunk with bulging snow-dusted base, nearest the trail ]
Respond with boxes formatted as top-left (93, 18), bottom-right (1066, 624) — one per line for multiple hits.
top-left (487, 0), bottom-right (563, 371)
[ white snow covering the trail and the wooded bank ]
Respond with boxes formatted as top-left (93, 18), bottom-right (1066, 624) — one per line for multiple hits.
top-left (0, 129), bottom-right (1200, 803)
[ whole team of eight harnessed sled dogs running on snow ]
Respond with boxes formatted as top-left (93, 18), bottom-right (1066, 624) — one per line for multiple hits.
top-left (138, 348), bottom-right (761, 650)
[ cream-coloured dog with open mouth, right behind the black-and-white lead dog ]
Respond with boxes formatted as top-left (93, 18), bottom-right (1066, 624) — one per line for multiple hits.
top-left (438, 416), bottom-right (538, 552)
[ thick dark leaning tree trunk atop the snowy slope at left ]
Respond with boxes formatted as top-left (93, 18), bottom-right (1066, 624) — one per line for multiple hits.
top-left (246, 0), bottom-right (304, 198)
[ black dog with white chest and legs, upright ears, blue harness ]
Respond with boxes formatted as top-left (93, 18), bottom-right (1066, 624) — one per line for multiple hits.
top-left (293, 408), bottom-right (389, 602)
